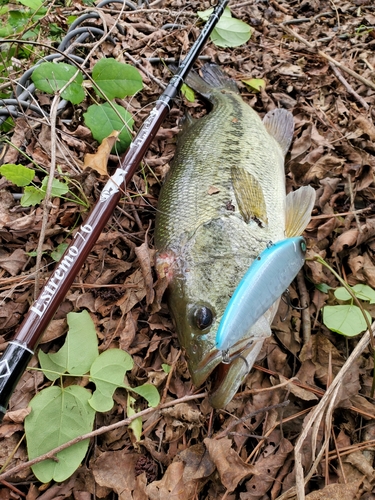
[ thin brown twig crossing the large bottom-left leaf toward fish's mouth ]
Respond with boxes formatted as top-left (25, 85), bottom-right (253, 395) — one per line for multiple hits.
top-left (0, 392), bottom-right (207, 481)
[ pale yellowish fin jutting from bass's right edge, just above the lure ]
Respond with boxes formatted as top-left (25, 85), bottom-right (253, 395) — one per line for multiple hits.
top-left (285, 186), bottom-right (315, 238)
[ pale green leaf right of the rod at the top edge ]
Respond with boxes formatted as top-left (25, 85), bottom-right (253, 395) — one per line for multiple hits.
top-left (197, 7), bottom-right (251, 47)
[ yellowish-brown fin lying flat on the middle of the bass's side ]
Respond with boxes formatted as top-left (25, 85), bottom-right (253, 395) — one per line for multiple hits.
top-left (231, 166), bottom-right (268, 227)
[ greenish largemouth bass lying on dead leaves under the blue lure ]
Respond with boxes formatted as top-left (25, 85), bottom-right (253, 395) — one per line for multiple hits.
top-left (155, 65), bottom-right (315, 408)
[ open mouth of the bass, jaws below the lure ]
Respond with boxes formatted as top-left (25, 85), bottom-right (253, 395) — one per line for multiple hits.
top-left (192, 339), bottom-right (264, 409)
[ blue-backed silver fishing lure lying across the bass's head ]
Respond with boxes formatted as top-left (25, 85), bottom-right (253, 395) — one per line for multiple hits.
top-left (216, 236), bottom-right (306, 354)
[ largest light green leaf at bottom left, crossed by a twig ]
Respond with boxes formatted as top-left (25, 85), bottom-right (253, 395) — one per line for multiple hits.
top-left (25, 385), bottom-right (95, 483)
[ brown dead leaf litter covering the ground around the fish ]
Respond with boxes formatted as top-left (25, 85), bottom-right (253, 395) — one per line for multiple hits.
top-left (0, 0), bottom-right (375, 500)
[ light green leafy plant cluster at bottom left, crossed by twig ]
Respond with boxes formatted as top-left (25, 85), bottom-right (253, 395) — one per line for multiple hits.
top-left (25, 311), bottom-right (160, 483)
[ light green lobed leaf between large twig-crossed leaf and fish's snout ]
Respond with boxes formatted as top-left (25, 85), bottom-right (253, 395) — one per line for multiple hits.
top-left (89, 349), bottom-right (133, 412)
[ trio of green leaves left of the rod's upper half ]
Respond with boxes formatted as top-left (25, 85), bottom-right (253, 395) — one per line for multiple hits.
top-left (32, 58), bottom-right (143, 154)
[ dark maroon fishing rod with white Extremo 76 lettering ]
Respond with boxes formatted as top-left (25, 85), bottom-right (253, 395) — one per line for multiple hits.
top-left (0, 0), bottom-right (229, 422)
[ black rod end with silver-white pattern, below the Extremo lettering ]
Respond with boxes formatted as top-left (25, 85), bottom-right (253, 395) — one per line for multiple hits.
top-left (0, 341), bottom-right (34, 423)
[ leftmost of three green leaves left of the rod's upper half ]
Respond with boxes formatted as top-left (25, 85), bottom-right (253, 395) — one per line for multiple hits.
top-left (31, 62), bottom-right (85, 104)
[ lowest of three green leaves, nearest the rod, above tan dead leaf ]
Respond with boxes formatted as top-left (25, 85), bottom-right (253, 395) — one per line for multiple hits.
top-left (83, 102), bottom-right (134, 153)
